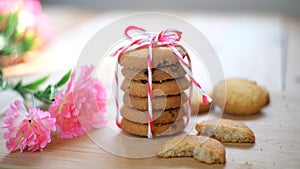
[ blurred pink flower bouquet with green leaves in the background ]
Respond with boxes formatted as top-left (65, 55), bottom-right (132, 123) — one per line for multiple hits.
top-left (0, 0), bottom-right (55, 67)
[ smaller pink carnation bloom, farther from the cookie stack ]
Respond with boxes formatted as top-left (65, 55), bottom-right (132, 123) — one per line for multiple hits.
top-left (2, 100), bottom-right (55, 152)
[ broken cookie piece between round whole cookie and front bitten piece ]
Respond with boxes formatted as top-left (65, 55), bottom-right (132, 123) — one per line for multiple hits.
top-left (195, 119), bottom-right (255, 143)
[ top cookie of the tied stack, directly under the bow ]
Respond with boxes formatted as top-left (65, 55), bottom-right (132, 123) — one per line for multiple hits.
top-left (119, 46), bottom-right (186, 69)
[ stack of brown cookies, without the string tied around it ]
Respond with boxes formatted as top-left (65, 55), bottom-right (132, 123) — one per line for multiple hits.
top-left (119, 47), bottom-right (190, 136)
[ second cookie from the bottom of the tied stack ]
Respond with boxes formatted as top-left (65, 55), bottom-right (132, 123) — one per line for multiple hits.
top-left (120, 105), bottom-right (185, 124)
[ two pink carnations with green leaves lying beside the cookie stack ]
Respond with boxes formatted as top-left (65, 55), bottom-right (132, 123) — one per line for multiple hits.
top-left (0, 65), bottom-right (107, 152)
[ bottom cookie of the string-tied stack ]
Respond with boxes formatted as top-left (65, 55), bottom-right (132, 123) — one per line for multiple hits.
top-left (121, 118), bottom-right (185, 137)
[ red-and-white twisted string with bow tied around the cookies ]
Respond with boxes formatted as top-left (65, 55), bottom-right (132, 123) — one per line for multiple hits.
top-left (112, 26), bottom-right (212, 138)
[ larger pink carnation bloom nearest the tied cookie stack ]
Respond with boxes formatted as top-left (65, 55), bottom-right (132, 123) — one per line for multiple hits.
top-left (49, 66), bottom-right (107, 138)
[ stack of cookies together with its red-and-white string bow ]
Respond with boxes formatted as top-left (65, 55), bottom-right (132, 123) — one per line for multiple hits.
top-left (113, 26), bottom-right (210, 138)
